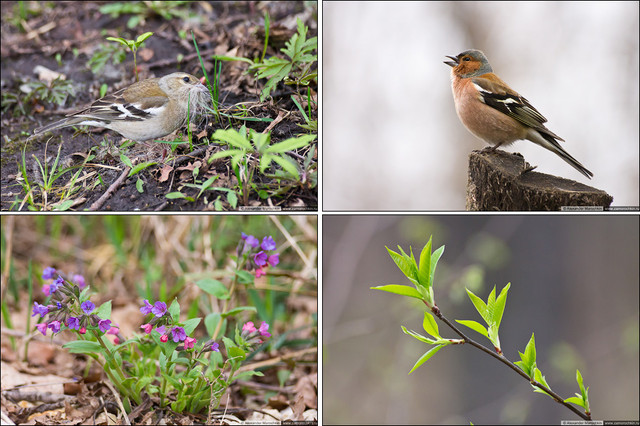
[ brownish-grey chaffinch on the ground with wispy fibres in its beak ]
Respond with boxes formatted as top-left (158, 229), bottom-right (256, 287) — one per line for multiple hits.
top-left (33, 72), bottom-right (207, 141)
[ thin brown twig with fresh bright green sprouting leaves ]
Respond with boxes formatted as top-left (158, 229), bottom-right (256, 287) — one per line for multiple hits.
top-left (371, 238), bottom-right (591, 420)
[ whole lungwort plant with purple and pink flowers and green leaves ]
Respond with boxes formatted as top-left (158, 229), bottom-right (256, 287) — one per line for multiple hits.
top-left (32, 232), bottom-right (280, 414)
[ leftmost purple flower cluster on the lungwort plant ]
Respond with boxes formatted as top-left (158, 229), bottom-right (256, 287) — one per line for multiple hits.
top-left (31, 267), bottom-right (122, 344)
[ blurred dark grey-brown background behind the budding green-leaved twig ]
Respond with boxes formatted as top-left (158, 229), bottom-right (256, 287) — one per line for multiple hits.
top-left (322, 215), bottom-right (639, 424)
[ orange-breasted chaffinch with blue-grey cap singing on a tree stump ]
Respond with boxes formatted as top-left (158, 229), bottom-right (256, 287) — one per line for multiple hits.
top-left (444, 49), bottom-right (593, 179)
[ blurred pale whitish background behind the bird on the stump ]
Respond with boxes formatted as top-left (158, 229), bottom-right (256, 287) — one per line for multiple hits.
top-left (322, 2), bottom-right (640, 211)
